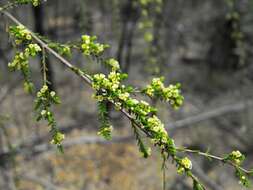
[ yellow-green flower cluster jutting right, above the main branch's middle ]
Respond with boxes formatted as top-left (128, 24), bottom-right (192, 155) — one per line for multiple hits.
top-left (143, 77), bottom-right (184, 108)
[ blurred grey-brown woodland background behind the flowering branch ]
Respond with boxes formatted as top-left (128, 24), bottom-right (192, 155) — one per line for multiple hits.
top-left (0, 0), bottom-right (253, 190)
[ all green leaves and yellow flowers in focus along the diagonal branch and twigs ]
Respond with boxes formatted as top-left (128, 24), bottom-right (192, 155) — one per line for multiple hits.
top-left (5, 20), bottom-right (253, 189)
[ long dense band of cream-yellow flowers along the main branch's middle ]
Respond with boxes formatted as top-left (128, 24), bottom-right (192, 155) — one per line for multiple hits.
top-left (92, 71), bottom-right (176, 155)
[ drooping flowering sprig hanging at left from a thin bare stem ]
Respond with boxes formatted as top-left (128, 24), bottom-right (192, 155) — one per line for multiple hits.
top-left (35, 85), bottom-right (64, 150)
